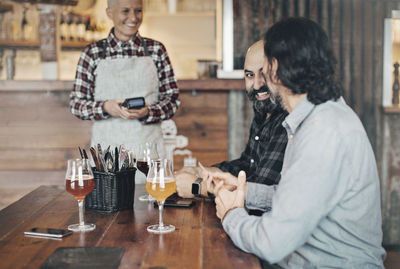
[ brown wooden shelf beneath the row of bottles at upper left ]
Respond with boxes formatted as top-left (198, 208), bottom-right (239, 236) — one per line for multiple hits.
top-left (0, 40), bottom-right (92, 50)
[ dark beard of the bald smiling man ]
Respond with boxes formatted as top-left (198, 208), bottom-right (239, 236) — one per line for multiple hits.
top-left (247, 85), bottom-right (281, 120)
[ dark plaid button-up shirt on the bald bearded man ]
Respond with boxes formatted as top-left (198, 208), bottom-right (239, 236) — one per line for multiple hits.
top-left (214, 108), bottom-right (288, 185)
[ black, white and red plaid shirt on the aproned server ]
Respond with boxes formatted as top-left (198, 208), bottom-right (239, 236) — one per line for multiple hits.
top-left (70, 29), bottom-right (180, 123)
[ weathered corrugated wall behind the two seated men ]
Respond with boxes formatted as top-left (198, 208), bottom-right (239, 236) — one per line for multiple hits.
top-left (234, 0), bottom-right (400, 246)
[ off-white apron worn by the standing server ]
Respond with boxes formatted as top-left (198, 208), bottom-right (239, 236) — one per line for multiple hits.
top-left (91, 39), bottom-right (162, 183)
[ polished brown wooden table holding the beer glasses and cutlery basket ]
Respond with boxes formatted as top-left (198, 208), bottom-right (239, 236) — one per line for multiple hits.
top-left (0, 185), bottom-right (261, 268)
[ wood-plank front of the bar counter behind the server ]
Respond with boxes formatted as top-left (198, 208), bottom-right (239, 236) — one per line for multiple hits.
top-left (0, 90), bottom-right (229, 170)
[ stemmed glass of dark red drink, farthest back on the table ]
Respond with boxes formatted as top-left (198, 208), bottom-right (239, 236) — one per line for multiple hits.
top-left (136, 142), bottom-right (159, 201)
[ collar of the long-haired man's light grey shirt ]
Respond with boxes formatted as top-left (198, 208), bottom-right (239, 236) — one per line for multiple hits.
top-left (282, 96), bottom-right (315, 134)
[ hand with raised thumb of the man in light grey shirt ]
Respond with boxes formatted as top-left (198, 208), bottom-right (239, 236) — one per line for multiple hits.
top-left (215, 171), bottom-right (247, 221)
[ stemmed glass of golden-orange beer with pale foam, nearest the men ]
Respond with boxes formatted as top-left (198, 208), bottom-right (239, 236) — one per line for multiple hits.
top-left (146, 159), bottom-right (176, 234)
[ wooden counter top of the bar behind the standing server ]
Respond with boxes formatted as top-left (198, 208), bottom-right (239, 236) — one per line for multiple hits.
top-left (0, 78), bottom-right (245, 91)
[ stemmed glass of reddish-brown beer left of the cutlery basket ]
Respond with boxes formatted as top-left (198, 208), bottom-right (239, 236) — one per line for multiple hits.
top-left (65, 159), bottom-right (96, 232)
